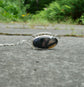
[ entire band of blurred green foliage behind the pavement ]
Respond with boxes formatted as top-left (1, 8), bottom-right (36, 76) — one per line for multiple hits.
top-left (0, 0), bottom-right (84, 24)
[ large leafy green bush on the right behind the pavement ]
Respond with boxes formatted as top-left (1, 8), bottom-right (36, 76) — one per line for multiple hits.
top-left (35, 0), bottom-right (84, 21)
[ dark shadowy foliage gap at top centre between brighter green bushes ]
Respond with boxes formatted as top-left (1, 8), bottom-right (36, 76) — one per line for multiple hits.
top-left (24, 0), bottom-right (55, 13)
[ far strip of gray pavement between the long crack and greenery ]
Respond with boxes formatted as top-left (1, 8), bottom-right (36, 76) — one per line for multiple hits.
top-left (0, 23), bottom-right (84, 35)
